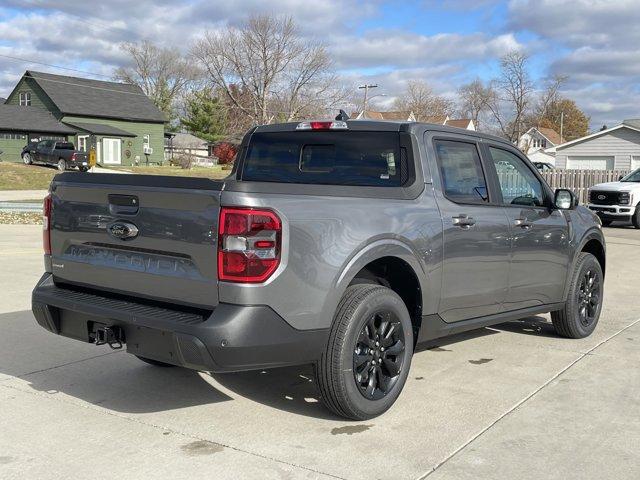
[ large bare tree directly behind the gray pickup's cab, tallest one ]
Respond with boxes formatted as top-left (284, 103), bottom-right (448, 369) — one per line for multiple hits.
top-left (191, 15), bottom-right (343, 124)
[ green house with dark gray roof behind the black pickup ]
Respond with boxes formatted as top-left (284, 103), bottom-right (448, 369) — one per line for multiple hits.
top-left (0, 70), bottom-right (166, 165)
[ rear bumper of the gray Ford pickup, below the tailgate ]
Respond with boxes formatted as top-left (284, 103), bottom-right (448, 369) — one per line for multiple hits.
top-left (32, 273), bottom-right (329, 372)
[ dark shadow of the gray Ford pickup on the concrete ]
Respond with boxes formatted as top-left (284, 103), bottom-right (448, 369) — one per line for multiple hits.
top-left (0, 311), bottom-right (555, 420)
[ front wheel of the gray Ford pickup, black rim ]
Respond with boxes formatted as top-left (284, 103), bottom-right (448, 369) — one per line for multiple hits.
top-left (551, 252), bottom-right (604, 338)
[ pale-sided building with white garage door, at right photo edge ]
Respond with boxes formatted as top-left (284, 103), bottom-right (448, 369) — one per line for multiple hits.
top-left (556, 119), bottom-right (640, 170)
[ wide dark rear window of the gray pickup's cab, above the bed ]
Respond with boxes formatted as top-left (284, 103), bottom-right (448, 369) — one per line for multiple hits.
top-left (242, 131), bottom-right (407, 187)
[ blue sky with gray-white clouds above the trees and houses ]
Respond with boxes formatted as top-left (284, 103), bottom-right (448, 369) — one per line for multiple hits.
top-left (0, 0), bottom-right (640, 128)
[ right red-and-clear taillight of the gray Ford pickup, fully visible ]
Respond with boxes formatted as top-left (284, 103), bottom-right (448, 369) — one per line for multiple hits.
top-left (218, 207), bottom-right (282, 283)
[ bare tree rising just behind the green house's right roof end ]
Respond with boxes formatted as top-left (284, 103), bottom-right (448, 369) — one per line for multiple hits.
top-left (114, 40), bottom-right (197, 119)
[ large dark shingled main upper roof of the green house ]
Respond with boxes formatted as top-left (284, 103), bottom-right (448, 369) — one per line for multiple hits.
top-left (24, 70), bottom-right (166, 123)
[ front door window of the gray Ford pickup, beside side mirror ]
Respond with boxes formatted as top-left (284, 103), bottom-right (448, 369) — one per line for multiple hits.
top-left (489, 147), bottom-right (544, 207)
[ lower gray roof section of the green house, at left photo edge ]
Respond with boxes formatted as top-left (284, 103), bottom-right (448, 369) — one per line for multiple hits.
top-left (0, 104), bottom-right (77, 135)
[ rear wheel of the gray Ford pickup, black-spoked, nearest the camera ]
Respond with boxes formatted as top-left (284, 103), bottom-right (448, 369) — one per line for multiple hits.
top-left (316, 284), bottom-right (413, 420)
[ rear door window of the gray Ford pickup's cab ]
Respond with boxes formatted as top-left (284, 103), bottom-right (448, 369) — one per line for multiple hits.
top-left (435, 140), bottom-right (489, 203)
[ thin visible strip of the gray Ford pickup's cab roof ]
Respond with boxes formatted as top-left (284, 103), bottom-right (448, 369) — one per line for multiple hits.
top-left (254, 119), bottom-right (511, 145)
